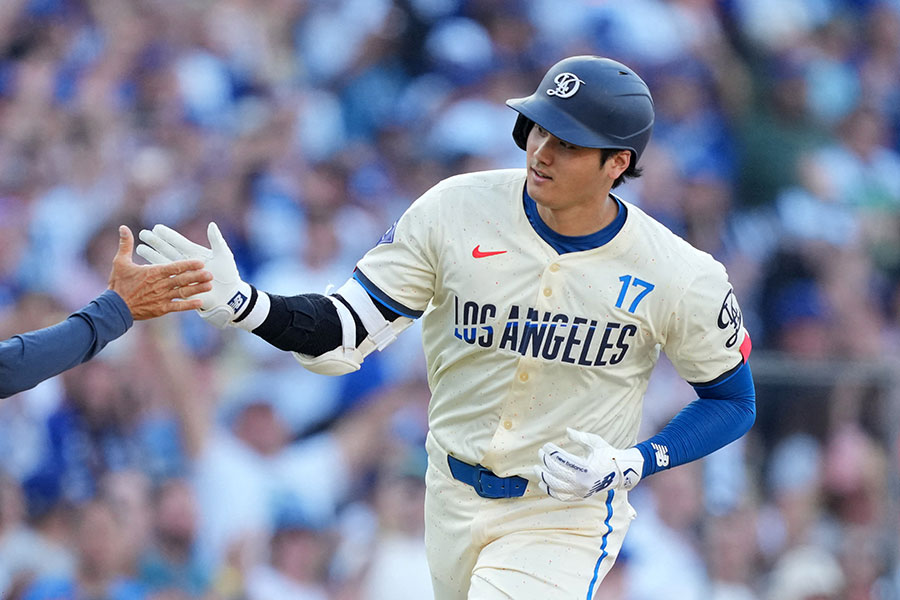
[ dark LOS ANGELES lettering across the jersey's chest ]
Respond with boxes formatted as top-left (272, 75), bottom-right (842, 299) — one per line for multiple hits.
top-left (453, 298), bottom-right (637, 367)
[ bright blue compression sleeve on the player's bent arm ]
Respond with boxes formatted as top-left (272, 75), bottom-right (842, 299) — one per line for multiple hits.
top-left (637, 363), bottom-right (756, 477)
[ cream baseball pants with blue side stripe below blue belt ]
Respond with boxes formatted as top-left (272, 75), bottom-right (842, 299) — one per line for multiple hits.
top-left (425, 435), bottom-right (635, 600)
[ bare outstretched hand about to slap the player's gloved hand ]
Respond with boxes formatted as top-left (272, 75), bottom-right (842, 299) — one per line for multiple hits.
top-left (109, 225), bottom-right (213, 321)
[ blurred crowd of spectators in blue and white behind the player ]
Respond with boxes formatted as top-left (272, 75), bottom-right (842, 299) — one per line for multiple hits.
top-left (0, 0), bottom-right (900, 600)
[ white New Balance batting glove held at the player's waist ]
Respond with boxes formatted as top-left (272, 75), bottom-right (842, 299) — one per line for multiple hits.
top-left (534, 427), bottom-right (644, 502)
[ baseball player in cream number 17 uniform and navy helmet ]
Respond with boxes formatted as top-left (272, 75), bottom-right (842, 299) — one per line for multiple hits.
top-left (138, 56), bottom-right (755, 600)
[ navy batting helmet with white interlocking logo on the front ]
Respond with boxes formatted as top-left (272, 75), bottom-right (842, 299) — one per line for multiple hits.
top-left (506, 56), bottom-right (654, 164)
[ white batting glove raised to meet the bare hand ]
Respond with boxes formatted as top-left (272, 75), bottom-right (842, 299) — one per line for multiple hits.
top-left (137, 223), bottom-right (252, 328)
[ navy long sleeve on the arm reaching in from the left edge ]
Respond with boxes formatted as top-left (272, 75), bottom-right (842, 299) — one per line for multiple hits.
top-left (0, 290), bottom-right (134, 398)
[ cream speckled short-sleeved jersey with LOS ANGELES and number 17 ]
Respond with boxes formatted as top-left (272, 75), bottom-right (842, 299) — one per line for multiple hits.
top-left (355, 169), bottom-right (749, 477)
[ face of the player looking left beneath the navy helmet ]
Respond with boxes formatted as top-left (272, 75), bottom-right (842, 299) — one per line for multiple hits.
top-left (525, 125), bottom-right (628, 225)
